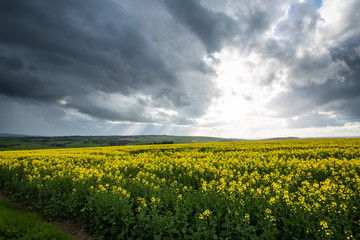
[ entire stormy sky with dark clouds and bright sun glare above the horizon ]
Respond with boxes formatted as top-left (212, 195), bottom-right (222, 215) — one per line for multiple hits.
top-left (0, 0), bottom-right (360, 138)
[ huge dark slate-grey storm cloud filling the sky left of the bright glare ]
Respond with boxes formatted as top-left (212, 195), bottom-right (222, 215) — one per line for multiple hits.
top-left (0, 0), bottom-right (219, 122)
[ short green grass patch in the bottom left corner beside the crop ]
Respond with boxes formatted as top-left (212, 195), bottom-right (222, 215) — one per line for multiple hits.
top-left (0, 197), bottom-right (76, 240)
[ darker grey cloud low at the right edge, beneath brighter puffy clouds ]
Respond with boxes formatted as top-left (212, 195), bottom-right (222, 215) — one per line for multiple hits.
top-left (271, 47), bottom-right (360, 123)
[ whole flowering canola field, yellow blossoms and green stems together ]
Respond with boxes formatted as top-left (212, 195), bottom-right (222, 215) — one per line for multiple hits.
top-left (0, 139), bottom-right (360, 239)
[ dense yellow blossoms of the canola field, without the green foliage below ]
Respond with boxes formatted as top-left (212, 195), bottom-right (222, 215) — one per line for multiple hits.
top-left (0, 139), bottom-right (360, 237)
